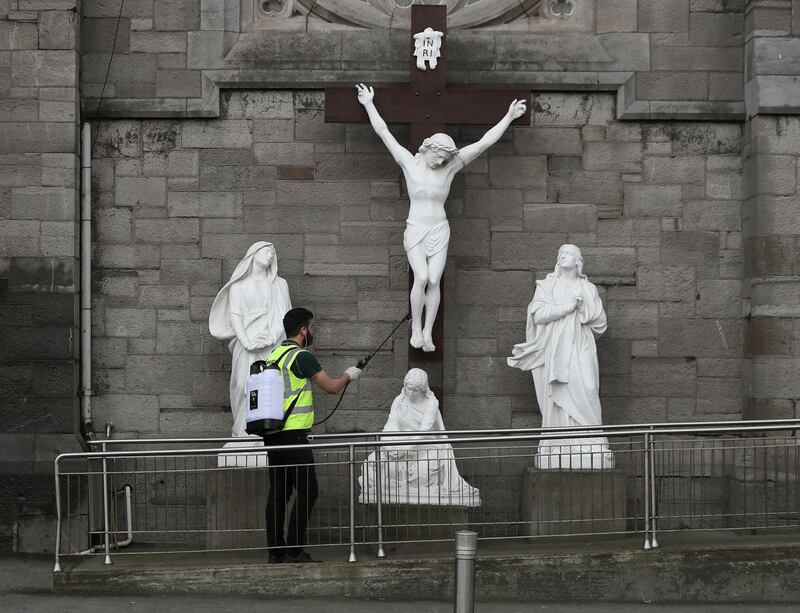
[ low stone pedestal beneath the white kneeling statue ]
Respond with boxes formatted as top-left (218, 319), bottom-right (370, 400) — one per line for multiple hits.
top-left (367, 504), bottom-right (469, 542)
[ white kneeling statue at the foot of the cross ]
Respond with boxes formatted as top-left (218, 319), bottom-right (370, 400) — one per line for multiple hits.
top-left (358, 368), bottom-right (481, 507)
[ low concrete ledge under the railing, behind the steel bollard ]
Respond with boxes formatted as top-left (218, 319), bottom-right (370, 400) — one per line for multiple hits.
top-left (53, 535), bottom-right (800, 603)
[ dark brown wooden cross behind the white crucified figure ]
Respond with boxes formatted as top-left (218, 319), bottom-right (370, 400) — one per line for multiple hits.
top-left (325, 4), bottom-right (530, 408)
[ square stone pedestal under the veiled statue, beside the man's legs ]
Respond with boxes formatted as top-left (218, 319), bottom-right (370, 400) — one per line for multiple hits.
top-left (206, 468), bottom-right (268, 549)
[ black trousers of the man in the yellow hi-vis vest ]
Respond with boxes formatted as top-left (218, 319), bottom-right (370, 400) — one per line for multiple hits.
top-left (264, 430), bottom-right (319, 553)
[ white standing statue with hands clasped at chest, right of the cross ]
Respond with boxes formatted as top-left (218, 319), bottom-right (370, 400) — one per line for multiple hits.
top-left (508, 245), bottom-right (614, 469)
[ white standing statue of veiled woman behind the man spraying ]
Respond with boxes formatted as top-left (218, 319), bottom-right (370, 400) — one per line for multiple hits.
top-left (208, 241), bottom-right (292, 437)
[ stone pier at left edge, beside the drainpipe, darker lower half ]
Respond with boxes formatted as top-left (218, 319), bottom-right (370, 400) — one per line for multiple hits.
top-left (0, 0), bottom-right (80, 550)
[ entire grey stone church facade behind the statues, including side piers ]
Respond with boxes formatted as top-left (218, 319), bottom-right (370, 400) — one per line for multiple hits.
top-left (0, 0), bottom-right (800, 550)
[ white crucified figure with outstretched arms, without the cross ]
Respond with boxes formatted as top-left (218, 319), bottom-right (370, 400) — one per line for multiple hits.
top-left (356, 84), bottom-right (526, 352)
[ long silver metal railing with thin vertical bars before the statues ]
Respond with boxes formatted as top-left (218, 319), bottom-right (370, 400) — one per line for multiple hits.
top-left (55, 420), bottom-right (800, 571)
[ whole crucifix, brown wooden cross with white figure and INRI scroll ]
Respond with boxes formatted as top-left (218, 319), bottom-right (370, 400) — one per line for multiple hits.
top-left (325, 5), bottom-right (530, 407)
